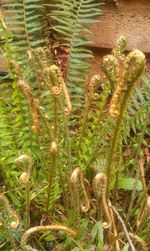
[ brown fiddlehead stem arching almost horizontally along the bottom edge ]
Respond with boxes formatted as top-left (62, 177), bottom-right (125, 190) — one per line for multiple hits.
top-left (20, 225), bottom-right (76, 251)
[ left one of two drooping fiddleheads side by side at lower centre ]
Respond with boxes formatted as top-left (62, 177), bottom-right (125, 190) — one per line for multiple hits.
top-left (70, 167), bottom-right (90, 213)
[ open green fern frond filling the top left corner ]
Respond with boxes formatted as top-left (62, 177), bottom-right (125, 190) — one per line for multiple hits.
top-left (2, 0), bottom-right (45, 60)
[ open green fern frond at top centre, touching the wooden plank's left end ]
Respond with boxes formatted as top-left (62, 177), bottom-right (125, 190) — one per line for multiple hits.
top-left (50, 0), bottom-right (101, 108)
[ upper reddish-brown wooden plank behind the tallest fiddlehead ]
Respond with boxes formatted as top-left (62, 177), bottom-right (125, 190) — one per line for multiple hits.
top-left (88, 0), bottom-right (150, 53)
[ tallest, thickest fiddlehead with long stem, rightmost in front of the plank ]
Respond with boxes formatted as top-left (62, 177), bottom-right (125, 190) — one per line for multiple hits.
top-left (106, 37), bottom-right (145, 197)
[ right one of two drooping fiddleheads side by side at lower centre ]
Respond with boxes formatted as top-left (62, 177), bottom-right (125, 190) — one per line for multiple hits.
top-left (93, 173), bottom-right (112, 228)
